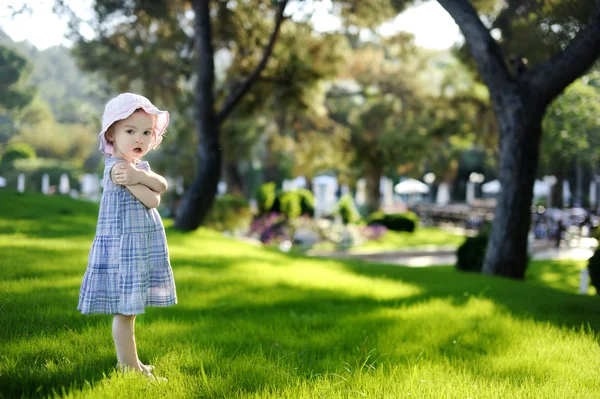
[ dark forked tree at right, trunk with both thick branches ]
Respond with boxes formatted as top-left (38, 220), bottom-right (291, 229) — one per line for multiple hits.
top-left (438, 0), bottom-right (600, 279)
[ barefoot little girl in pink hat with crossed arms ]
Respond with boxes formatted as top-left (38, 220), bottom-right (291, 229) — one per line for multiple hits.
top-left (77, 93), bottom-right (177, 378)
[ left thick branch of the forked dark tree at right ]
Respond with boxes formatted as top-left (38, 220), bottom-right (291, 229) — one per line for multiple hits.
top-left (438, 0), bottom-right (513, 96)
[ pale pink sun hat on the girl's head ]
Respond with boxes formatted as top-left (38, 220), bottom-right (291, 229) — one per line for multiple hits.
top-left (98, 93), bottom-right (169, 155)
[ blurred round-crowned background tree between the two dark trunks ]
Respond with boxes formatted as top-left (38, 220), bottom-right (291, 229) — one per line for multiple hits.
top-left (328, 40), bottom-right (439, 212)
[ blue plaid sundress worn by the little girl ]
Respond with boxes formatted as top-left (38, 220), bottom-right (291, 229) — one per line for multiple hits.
top-left (77, 157), bottom-right (177, 315)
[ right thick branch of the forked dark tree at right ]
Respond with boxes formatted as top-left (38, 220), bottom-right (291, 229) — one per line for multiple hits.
top-left (525, 0), bottom-right (600, 106)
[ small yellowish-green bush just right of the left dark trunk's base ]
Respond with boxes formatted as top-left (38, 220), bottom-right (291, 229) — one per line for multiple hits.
top-left (204, 194), bottom-right (252, 232)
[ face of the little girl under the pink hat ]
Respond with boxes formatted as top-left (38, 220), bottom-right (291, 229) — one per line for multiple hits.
top-left (106, 111), bottom-right (154, 161)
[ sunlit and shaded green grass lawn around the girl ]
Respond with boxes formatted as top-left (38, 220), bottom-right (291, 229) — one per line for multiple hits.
top-left (0, 191), bottom-right (600, 399)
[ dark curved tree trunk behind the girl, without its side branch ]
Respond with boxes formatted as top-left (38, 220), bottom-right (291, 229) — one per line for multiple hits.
top-left (175, 0), bottom-right (222, 231)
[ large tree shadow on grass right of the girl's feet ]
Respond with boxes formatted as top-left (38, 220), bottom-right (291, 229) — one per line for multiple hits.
top-left (137, 284), bottom-right (511, 397)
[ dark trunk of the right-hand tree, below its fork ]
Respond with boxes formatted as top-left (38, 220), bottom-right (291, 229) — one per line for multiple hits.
top-left (483, 91), bottom-right (542, 279)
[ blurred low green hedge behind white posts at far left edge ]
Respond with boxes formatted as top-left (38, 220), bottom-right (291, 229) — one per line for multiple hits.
top-left (5, 158), bottom-right (81, 192)
